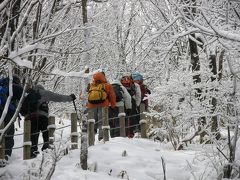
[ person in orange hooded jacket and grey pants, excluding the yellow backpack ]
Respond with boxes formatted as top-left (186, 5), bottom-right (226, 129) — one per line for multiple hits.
top-left (87, 72), bottom-right (116, 141)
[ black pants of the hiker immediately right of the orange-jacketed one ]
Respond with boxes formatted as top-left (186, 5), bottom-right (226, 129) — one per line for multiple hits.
top-left (109, 107), bottom-right (120, 138)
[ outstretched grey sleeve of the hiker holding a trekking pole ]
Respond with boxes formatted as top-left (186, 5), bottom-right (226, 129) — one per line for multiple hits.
top-left (39, 89), bottom-right (72, 102)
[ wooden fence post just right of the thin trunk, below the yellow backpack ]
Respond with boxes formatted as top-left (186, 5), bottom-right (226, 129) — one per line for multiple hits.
top-left (88, 111), bottom-right (95, 146)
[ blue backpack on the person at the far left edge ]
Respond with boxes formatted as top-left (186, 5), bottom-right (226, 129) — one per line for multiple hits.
top-left (0, 78), bottom-right (16, 111)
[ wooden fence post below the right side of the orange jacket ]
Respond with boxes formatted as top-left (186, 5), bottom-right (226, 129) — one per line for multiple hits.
top-left (102, 107), bottom-right (110, 142)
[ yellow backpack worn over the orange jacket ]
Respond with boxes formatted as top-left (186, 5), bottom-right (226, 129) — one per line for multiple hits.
top-left (88, 83), bottom-right (107, 104)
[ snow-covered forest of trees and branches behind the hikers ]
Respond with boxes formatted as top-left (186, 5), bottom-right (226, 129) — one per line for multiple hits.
top-left (0, 0), bottom-right (240, 178)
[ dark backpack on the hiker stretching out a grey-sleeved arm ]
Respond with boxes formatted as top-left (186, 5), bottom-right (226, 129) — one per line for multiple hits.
top-left (20, 89), bottom-right (49, 116)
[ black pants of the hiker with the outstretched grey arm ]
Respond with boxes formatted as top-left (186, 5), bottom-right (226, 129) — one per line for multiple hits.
top-left (30, 116), bottom-right (49, 153)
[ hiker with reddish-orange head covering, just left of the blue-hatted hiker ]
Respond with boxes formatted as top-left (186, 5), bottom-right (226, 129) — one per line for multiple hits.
top-left (121, 75), bottom-right (141, 138)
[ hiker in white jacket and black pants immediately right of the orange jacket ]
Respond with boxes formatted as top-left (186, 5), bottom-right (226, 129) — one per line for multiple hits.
top-left (109, 80), bottom-right (132, 138)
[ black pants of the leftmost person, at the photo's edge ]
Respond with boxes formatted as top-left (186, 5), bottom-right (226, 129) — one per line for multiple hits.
top-left (0, 111), bottom-right (15, 156)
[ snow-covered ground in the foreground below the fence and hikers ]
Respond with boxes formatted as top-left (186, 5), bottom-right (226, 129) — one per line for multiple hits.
top-left (0, 120), bottom-right (221, 180)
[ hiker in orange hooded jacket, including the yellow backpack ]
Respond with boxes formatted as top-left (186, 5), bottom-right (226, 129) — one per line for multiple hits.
top-left (87, 72), bottom-right (116, 141)
